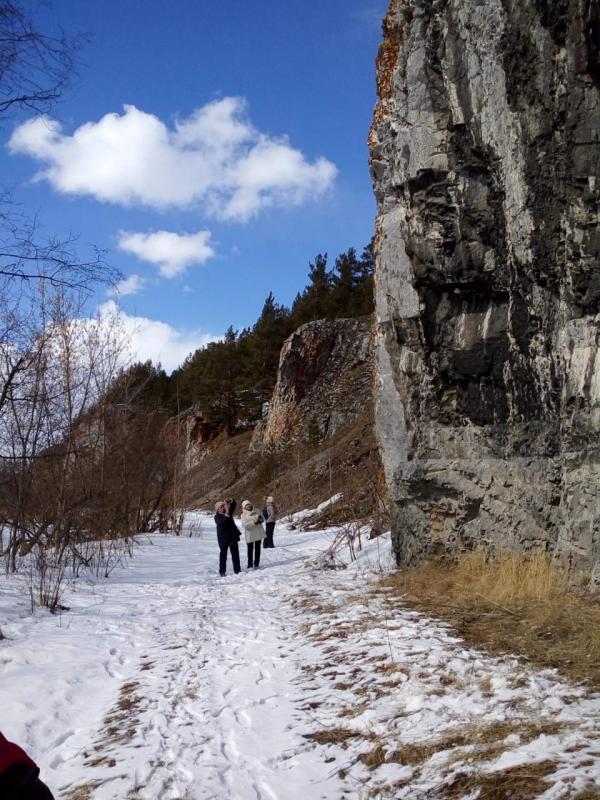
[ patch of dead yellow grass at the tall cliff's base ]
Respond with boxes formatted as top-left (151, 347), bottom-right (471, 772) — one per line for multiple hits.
top-left (381, 553), bottom-right (600, 688)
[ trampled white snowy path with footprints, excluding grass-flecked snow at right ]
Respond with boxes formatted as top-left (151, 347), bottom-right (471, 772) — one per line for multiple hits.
top-left (0, 515), bottom-right (352, 800)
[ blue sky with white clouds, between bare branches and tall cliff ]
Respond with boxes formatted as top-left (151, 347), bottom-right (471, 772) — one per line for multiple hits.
top-left (0, 0), bottom-right (387, 369)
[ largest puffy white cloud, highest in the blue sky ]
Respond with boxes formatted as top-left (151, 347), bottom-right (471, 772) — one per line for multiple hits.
top-left (8, 97), bottom-right (337, 222)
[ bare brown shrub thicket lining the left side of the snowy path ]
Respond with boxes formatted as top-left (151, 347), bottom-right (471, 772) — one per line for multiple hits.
top-left (0, 292), bottom-right (186, 592)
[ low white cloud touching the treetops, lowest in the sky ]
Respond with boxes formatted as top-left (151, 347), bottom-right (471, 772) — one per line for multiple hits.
top-left (99, 300), bottom-right (219, 372)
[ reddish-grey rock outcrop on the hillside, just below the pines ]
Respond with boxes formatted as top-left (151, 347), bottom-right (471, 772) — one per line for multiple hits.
top-left (252, 318), bottom-right (374, 450)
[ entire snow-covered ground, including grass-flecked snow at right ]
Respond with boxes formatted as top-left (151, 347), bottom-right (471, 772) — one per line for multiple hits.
top-left (0, 513), bottom-right (600, 800)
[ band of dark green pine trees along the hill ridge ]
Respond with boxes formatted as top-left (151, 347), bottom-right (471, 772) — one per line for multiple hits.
top-left (145, 234), bottom-right (374, 434)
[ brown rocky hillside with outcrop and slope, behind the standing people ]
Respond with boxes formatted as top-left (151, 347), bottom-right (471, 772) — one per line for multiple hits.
top-left (188, 317), bottom-right (381, 521)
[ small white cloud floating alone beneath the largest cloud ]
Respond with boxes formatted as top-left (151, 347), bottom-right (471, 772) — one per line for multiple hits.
top-left (119, 231), bottom-right (215, 278)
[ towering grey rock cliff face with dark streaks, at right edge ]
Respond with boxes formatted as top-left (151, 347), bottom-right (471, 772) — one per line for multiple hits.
top-left (370, 0), bottom-right (600, 581)
